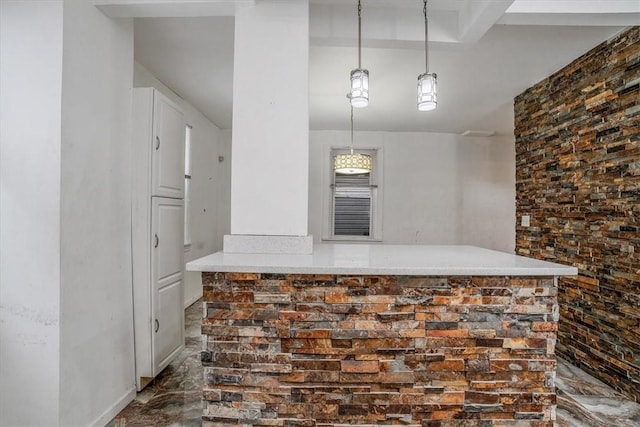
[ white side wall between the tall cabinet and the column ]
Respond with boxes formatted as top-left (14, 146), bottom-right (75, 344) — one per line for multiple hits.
top-left (133, 62), bottom-right (230, 307)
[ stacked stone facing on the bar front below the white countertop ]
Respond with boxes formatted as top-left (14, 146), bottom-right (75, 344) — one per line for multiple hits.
top-left (202, 273), bottom-right (558, 427)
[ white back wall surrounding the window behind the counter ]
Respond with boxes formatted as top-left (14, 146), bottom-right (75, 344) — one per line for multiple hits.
top-left (309, 131), bottom-right (515, 253)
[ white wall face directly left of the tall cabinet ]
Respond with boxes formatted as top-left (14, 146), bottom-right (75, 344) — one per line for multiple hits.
top-left (60, 0), bottom-right (135, 426)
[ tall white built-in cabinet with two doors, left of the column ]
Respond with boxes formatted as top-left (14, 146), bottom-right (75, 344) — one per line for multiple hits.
top-left (132, 88), bottom-right (185, 390)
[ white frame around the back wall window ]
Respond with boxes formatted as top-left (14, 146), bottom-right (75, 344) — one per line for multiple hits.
top-left (322, 145), bottom-right (384, 242)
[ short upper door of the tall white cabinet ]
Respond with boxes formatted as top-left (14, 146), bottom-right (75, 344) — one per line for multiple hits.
top-left (151, 91), bottom-right (185, 199)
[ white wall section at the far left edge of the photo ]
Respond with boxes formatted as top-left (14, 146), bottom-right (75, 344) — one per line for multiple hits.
top-left (0, 0), bottom-right (63, 426)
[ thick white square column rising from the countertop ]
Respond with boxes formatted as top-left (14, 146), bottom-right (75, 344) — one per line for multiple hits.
top-left (224, 0), bottom-right (312, 253)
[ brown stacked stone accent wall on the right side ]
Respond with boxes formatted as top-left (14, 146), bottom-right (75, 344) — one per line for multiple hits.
top-left (515, 27), bottom-right (640, 401)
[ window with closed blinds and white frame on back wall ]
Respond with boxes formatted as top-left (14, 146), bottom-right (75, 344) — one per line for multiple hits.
top-left (323, 148), bottom-right (382, 241)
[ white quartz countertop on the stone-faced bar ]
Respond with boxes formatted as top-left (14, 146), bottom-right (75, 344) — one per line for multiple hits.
top-left (187, 244), bottom-right (578, 276)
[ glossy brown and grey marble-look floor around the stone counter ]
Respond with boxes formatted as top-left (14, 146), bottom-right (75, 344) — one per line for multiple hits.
top-left (107, 301), bottom-right (640, 427)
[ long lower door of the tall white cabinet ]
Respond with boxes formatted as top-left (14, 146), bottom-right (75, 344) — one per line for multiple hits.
top-left (151, 197), bottom-right (184, 376)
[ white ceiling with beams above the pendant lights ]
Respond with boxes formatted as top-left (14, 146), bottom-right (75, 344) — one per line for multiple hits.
top-left (126, 0), bottom-right (640, 134)
